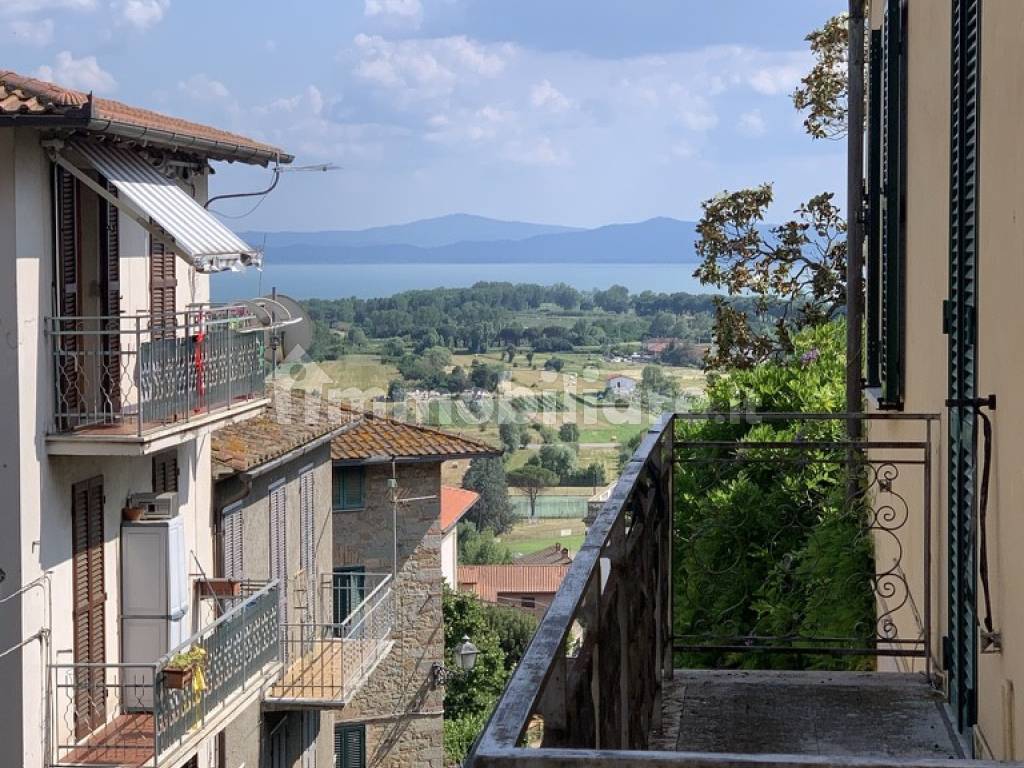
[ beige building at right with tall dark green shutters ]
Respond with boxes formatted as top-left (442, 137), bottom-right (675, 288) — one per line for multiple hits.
top-left (866, 0), bottom-right (1024, 760)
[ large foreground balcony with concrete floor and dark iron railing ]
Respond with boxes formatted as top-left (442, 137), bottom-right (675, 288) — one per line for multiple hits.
top-left (468, 413), bottom-right (995, 768)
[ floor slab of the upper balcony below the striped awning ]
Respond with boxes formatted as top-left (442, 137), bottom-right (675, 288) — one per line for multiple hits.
top-left (46, 397), bottom-right (270, 456)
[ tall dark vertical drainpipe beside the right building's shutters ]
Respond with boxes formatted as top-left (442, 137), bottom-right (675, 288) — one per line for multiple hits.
top-left (846, 0), bottom-right (864, 440)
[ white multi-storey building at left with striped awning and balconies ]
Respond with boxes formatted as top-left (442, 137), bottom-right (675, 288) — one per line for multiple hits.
top-left (0, 71), bottom-right (291, 768)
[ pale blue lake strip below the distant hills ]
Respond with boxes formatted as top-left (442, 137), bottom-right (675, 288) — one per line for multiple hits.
top-left (211, 263), bottom-right (709, 300)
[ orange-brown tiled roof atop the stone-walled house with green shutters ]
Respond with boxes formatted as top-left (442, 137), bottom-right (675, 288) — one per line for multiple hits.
top-left (331, 414), bottom-right (502, 462)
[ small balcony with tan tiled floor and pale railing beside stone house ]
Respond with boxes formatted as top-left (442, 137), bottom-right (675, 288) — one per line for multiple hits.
top-left (264, 573), bottom-right (394, 709)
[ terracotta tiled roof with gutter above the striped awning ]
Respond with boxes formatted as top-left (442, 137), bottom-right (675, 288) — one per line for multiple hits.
top-left (0, 70), bottom-right (292, 163)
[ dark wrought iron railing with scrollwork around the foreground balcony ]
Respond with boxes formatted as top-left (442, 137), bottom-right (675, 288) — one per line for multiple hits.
top-left (468, 414), bottom-right (937, 768)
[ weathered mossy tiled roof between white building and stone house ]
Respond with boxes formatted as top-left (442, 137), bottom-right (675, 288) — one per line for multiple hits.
top-left (211, 390), bottom-right (360, 479)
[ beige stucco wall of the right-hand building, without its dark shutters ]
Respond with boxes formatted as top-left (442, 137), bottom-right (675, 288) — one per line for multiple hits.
top-left (868, 0), bottom-right (1024, 760)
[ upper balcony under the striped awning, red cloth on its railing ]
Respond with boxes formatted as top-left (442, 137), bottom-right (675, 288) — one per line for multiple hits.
top-left (46, 306), bottom-right (266, 455)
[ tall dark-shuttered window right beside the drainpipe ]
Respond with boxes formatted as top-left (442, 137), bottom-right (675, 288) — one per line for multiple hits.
top-left (865, 0), bottom-right (907, 409)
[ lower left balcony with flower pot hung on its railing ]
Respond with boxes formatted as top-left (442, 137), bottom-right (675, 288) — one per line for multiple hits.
top-left (49, 582), bottom-right (281, 768)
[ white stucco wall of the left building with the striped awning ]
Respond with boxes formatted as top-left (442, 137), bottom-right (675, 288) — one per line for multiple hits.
top-left (0, 129), bottom-right (221, 768)
